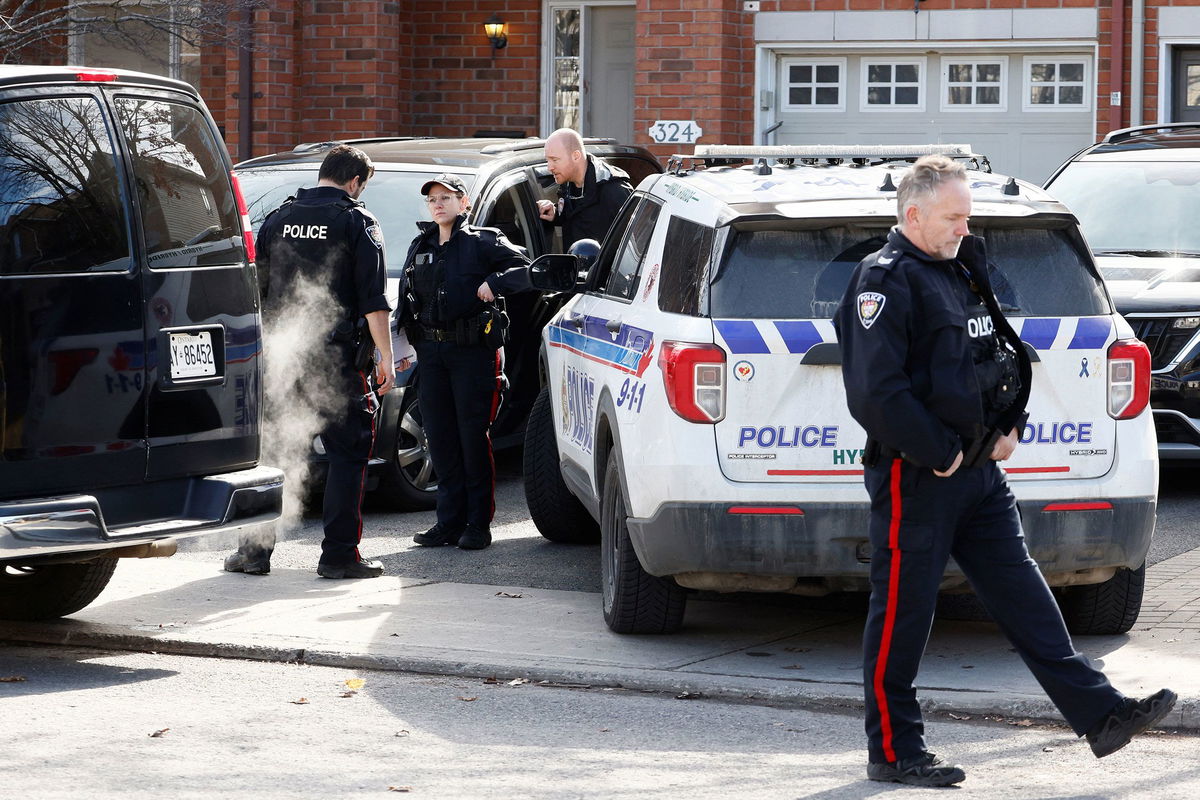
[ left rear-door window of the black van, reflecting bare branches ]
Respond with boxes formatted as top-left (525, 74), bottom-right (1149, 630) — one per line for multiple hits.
top-left (0, 97), bottom-right (130, 275)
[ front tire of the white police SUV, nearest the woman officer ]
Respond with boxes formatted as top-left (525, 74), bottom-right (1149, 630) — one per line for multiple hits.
top-left (522, 386), bottom-right (600, 545)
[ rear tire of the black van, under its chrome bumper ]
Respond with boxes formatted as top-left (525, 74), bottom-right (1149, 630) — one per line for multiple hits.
top-left (0, 558), bottom-right (116, 620)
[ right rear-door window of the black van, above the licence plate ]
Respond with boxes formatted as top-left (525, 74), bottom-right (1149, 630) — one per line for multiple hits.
top-left (116, 97), bottom-right (244, 269)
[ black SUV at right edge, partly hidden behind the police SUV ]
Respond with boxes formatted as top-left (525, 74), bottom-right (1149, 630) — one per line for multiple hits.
top-left (1045, 122), bottom-right (1200, 459)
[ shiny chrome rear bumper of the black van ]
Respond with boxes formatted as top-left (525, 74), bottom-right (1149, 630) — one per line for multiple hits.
top-left (0, 467), bottom-right (283, 564)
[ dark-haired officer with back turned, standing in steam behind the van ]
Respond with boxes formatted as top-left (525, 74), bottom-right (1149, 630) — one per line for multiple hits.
top-left (224, 145), bottom-right (396, 578)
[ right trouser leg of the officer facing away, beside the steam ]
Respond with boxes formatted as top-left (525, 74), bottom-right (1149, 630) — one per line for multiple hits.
top-left (320, 369), bottom-right (378, 566)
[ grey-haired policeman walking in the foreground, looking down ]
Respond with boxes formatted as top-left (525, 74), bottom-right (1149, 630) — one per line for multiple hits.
top-left (834, 156), bottom-right (1175, 786)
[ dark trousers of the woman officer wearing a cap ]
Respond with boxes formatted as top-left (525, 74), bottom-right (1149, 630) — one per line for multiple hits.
top-left (415, 341), bottom-right (503, 530)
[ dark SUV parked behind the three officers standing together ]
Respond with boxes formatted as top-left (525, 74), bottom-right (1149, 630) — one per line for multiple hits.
top-left (234, 138), bottom-right (662, 510)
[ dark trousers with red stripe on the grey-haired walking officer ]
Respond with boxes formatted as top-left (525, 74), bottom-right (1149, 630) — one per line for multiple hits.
top-left (863, 458), bottom-right (1123, 762)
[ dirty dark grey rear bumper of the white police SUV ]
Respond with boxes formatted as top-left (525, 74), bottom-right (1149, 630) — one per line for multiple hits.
top-left (628, 497), bottom-right (1157, 589)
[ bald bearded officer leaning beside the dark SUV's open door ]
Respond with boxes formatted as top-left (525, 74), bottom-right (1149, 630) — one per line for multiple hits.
top-left (538, 128), bottom-right (634, 251)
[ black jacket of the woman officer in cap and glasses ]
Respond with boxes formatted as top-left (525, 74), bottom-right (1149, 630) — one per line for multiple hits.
top-left (396, 216), bottom-right (533, 326)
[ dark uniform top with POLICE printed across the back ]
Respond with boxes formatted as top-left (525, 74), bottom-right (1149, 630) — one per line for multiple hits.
top-left (254, 186), bottom-right (389, 320)
